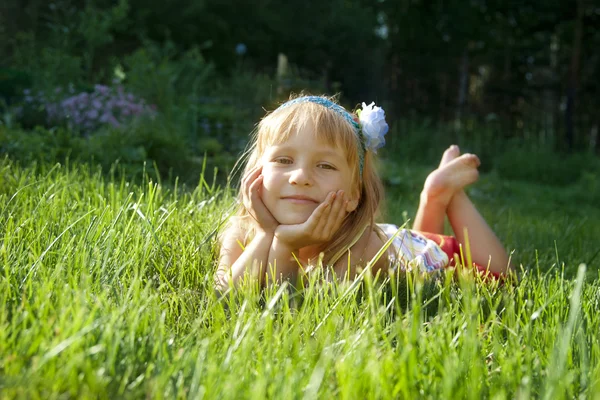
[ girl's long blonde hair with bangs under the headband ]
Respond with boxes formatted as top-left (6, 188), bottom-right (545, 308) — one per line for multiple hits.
top-left (230, 96), bottom-right (384, 265)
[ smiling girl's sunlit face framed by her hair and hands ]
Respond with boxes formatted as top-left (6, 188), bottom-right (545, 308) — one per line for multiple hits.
top-left (261, 125), bottom-right (358, 225)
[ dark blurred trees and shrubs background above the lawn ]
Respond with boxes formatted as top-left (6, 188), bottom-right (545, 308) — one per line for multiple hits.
top-left (0, 0), bottom-right (600, 186)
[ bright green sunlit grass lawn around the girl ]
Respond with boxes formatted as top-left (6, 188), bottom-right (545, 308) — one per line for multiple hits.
top-left (0, 160), bottom-right (600, 399)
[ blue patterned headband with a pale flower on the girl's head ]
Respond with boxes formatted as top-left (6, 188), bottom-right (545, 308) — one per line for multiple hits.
top-left (279, 96), bottom-right (389, 178)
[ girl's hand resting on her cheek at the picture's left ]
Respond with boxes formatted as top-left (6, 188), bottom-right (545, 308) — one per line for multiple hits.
top-left (241, 165), bottom-right (279, 233)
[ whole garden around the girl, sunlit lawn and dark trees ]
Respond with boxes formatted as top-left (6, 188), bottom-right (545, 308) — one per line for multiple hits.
top-left (0, 0), bottom-right (600, 399)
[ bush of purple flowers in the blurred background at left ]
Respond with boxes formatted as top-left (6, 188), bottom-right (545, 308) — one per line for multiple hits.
top-left (19, 85), bottom-right (156, 135)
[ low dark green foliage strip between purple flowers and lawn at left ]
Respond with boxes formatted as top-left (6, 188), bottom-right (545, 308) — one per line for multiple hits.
top-left (0, 117), bottom-right (193, 182)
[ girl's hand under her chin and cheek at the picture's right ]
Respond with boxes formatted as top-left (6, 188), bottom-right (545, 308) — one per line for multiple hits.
top-left (275, 190), bottom-right (348, 249)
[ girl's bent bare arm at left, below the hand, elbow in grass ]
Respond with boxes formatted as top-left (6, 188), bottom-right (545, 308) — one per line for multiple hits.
top-left (215, 221), bottom-right (273, 291)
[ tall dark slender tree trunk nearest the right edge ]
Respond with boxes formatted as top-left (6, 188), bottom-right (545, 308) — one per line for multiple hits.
top-left (565, 0), bottom-right (583, 151)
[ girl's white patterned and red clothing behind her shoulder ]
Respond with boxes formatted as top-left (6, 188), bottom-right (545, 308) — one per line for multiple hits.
top-left (377, 224), bottom-right (501, 278)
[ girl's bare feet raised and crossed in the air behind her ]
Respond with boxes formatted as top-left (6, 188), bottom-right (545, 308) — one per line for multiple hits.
top-left (421, 152), bottom-right (480, 207)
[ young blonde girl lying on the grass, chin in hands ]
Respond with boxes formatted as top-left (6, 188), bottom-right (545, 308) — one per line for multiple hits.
top-left (216, 96), bottom-right (509, 290)
